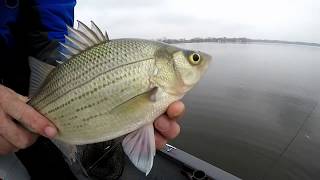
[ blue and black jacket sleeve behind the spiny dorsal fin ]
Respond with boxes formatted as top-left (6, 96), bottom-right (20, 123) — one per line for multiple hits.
top-left (21, 0), bottom-right (76, 64)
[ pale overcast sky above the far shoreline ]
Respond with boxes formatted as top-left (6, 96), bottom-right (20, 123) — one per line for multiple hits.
top-left (75, 0), bottom-right (320, 43)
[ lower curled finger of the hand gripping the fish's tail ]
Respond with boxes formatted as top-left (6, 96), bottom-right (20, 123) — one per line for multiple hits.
top-left (0, 113), bottom-right (37, 149)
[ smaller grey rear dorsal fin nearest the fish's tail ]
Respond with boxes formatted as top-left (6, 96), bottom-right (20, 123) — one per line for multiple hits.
top-left (29, 57), bottom-right (55, 97)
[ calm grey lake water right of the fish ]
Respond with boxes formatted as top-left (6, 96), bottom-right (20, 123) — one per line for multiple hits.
top-left (172, 43), bottom-right (320, 179)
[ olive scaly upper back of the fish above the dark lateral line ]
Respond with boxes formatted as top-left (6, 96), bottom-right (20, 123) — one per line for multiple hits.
top-left (33, 39), bottom-right (160, 109)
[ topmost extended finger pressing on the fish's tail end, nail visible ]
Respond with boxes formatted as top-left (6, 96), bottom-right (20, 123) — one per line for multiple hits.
top-left (1, 93), bottom-right (57, 138)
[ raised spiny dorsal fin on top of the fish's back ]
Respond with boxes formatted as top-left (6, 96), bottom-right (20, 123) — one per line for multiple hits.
top-left (58, 21), bottom-right (109, 64)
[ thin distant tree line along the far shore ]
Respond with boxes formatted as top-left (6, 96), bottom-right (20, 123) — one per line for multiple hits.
top-left (158, 37), bottom-right (320, 47)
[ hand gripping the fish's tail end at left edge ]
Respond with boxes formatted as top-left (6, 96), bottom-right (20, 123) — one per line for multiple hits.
top-left (0, 85), bottom-right (57, 155)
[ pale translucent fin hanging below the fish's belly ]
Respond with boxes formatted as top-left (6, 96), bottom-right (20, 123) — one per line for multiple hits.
top-left (122, 123), bottom-right (156, 175)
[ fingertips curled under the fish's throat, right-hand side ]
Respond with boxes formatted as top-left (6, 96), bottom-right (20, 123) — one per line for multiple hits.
top-left (154, 101), bottom-right (185, 149)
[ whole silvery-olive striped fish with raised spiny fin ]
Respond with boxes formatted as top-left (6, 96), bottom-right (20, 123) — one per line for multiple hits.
top-left (29, 22), bottom-right (211, 174)
